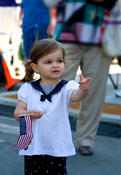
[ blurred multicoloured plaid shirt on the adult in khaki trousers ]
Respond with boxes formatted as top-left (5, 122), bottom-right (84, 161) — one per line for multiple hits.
top-left (53, 0), bottom-right (116, 45)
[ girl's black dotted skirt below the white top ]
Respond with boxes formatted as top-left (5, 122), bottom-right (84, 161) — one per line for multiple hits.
top-left (24, 155), bottom-right (67, 175)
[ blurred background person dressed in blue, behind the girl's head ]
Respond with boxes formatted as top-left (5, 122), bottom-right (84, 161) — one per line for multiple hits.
top-left (19, 0), bottom-right (50, 60)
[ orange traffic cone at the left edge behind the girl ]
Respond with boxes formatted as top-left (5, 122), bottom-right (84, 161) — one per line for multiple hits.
top-left (0, 50), bottom-right (21, 90)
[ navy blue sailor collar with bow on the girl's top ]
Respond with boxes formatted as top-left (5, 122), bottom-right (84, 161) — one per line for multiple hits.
top-left (31, 79), bottom-right (68, 102)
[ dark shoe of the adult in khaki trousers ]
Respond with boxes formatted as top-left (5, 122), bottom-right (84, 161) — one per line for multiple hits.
top-left (79, 146), bottom-right (94, 156)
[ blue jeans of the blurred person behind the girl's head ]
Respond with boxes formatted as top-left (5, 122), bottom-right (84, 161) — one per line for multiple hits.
top-left (23, 24), bottom-right (48, 60)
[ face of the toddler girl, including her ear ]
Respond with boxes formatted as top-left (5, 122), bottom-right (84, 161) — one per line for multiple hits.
top-left (31, 49), bottom-right (65, 83)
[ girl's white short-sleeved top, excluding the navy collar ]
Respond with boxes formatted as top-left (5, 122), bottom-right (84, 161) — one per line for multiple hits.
top-left (18, 80), bottom-right (79, 157)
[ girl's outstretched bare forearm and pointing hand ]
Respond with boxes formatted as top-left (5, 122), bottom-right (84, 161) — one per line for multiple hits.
top-left (70, 74), bottom-right (90, 102)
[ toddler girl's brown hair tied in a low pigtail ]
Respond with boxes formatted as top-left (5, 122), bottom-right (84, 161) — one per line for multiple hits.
top-left (25, 39), bottom-right (65, 81)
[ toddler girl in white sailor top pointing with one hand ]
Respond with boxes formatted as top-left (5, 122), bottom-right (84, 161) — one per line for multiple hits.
top-left (14, 39), bottom-right (90, 175)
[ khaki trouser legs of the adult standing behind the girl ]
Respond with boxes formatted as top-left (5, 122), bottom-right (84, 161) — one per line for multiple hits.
top-left (76, 46), bottom-right (112, 152)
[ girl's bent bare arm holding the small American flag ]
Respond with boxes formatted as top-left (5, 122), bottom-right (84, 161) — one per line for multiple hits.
top-left (14, 100), bottom-right (43, 121)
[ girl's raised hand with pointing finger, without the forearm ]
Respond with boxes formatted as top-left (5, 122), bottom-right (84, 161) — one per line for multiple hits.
top-left (79, 74), bottom-right (90, 94)
